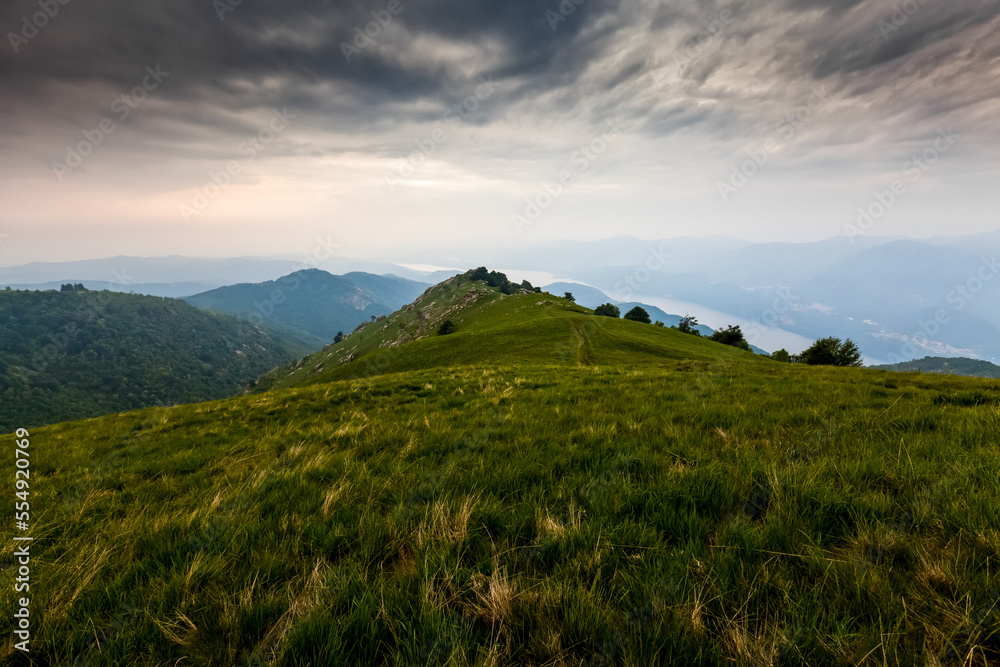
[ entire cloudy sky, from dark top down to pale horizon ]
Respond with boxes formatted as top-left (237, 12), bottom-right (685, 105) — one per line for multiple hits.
top-left (0, 0), bottom-right (1000, 265)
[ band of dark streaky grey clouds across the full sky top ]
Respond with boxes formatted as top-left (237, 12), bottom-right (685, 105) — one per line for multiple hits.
top-left (0, 0), bottom-right (1000, 177)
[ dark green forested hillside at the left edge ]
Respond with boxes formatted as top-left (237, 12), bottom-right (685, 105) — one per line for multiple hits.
top-left (0, 290), bottom-right (308, 432)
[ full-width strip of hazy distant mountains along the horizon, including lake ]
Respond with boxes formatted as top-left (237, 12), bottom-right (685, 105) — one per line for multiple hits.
top-left (0, 232), bottom-right (1000, 363)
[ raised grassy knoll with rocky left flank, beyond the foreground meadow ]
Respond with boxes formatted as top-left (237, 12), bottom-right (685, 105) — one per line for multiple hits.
top-left (255, 275), bottom-right (752, 391)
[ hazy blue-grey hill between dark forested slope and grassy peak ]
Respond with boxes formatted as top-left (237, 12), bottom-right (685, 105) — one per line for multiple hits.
top-left (184, 269), bottom-right (427, 350)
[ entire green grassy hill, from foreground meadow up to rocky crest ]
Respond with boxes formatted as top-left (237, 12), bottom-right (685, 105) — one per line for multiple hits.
top-left (0, 279), bottom-right (1000, 666)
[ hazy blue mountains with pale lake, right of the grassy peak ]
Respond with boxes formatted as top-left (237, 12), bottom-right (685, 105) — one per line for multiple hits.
top-left (390, 231), bottom-right (1000, 363)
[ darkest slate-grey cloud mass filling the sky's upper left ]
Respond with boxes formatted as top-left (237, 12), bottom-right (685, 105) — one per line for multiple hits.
top-left (0, 0), bottom-right (610, 111)
